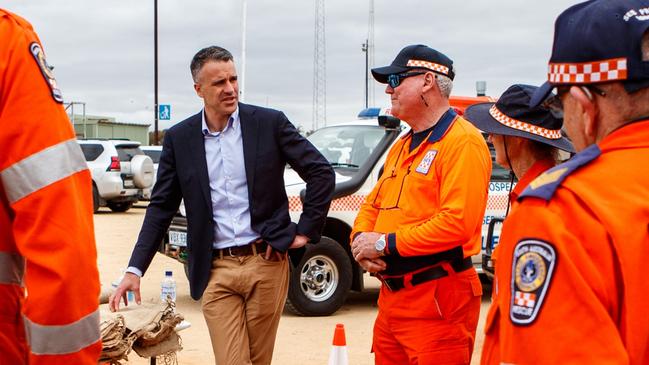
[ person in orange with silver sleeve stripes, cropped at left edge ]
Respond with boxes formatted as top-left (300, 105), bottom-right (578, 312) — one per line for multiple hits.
top-left (0, 9), bottom-right (101, 365)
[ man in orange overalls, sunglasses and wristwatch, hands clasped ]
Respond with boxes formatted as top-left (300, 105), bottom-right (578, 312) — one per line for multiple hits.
top-left (352, 45), bottom-right (491, 365)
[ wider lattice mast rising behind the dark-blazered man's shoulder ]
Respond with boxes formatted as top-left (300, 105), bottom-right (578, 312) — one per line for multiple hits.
top-left (313, 0), bottom-right (327, 130)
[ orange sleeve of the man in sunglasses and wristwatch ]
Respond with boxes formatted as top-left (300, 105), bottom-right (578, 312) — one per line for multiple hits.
top-left (388, 135), bottom-right (491, 256)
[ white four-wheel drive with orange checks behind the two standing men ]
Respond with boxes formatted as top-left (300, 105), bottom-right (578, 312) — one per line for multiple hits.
top-left (160, 98), bottom-right (510, 316)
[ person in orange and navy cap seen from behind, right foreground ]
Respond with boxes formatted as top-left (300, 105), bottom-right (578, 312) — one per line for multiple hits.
top-left (481, 0), bottom-right (649, 365)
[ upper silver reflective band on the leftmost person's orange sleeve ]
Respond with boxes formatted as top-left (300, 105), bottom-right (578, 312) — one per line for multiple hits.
top-left (0, 139), bottom-right (88, 204)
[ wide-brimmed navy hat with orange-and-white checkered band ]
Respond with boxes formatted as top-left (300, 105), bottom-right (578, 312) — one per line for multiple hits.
top-left (464, 84), bottom-right (575, 152)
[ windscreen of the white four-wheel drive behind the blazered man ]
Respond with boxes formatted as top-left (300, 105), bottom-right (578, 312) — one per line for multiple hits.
top-left (308, 125), bottom-right (385, 168)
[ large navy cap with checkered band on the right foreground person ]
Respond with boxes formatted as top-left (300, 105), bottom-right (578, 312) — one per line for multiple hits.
top-left (530, 0), bottom-right (649, 106)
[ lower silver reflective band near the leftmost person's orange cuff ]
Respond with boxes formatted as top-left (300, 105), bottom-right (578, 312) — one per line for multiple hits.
top-left (23, 308), bottom-right (100, 355)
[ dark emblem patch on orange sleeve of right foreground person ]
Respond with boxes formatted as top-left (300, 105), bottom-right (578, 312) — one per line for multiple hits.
top-left (509, 239), bottom-right (557, 325)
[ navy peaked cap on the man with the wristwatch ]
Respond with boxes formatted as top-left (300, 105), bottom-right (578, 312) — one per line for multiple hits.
top-left (372, 44), bottom-right (455, 84)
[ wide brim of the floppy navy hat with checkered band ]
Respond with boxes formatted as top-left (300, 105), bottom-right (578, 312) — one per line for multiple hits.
top-left (463, 103), bottom-right (575, 152)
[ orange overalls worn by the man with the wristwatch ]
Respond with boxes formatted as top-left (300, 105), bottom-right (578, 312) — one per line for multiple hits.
top-left (352, 111), bottom-right (491, 364)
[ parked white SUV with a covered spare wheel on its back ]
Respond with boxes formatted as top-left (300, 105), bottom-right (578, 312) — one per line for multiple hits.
top-left (78, 139), bottom-right (153, 212)
